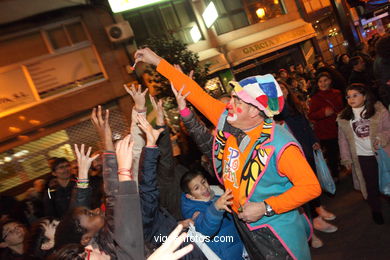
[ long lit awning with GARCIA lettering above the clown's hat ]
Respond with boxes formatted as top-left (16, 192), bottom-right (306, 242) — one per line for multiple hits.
top-left (226, 19), bottom-right (316, 66)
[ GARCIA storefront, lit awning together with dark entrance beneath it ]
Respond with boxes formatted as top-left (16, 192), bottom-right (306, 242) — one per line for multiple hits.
top-left (226, 20), bottom-right (316, 80)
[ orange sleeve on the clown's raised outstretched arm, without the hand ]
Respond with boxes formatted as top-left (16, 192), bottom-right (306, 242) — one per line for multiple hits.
top-left (157, 60), bottom-right (226, 126)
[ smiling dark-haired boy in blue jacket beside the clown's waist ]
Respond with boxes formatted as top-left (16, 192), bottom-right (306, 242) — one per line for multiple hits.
top-left (180, 172), bottom-right (244, 259)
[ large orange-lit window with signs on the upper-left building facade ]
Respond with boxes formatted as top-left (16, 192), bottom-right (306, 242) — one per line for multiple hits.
top-left (0, 18), bottom-right (106, 112)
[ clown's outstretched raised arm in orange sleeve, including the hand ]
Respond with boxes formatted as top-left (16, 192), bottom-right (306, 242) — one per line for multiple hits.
top-left (135, 48), bottom-right (225, 125)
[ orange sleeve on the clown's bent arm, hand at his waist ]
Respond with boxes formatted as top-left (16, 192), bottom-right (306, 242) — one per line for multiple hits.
top-left (265, 145), bottom-right (321, 214)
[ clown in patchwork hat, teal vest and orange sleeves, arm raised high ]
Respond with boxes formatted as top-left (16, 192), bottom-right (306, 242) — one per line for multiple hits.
top-left (135, 48), bottom-right (321, 259)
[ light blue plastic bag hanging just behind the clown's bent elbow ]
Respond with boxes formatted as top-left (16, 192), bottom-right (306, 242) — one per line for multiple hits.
top-left (313, 150), bottom-right (336, 194)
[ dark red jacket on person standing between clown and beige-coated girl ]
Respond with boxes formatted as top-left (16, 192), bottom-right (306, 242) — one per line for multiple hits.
top-left (308, 89), bottom-right (343, 140)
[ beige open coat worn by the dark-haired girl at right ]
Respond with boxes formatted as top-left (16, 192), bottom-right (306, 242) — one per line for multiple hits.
top-left (337, 102), bottom-right (390, 199)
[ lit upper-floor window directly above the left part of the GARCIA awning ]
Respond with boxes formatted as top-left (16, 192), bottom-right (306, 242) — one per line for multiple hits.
top-left (205, 0), bottom-right (249, 35)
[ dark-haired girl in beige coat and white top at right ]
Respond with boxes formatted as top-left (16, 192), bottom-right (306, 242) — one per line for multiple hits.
top-left (337, 84), bottom-right (390, 225)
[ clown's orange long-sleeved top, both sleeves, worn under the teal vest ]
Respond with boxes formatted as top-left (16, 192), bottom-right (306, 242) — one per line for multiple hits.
top-left (157, 60), bottom-right (321, 214)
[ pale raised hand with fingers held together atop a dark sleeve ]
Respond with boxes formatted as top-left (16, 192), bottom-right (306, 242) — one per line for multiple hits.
top-left (116, 135), bottom-right (134, 181)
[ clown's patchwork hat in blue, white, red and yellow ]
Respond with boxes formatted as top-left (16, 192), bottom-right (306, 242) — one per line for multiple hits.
top-left (229, 74), bottom-right (284, 117)
